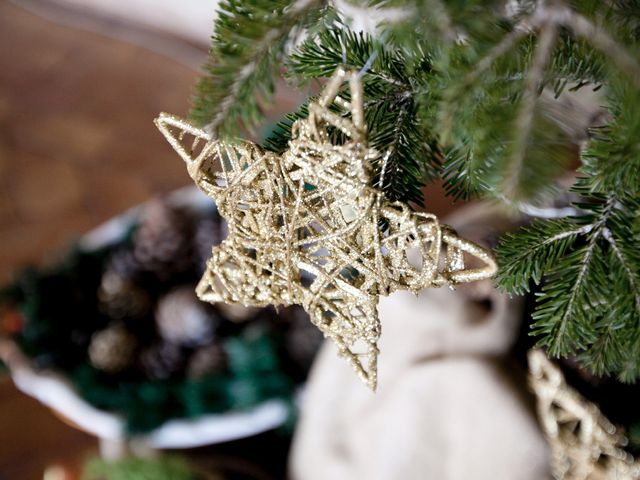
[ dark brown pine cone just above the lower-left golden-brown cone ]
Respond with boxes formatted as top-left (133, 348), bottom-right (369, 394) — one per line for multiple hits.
top-left (98, 270), bottom-right (151, 320)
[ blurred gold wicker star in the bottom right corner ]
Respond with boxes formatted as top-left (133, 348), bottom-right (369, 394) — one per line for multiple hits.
top-left (529, 350), bottom-right (640, 480)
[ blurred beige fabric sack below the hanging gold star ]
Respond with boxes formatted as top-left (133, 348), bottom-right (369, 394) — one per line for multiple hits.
top-left (290, 208), bottom-right (550, 480)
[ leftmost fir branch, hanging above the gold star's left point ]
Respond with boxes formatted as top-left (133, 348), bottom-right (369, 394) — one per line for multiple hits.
top-left (191, 0), bottom-right (324, 137)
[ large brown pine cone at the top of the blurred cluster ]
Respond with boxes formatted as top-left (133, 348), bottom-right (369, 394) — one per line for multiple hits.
top-left (133, 200), bottom-right (193, 281)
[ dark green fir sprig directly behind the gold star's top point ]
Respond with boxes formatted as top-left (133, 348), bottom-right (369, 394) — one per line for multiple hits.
top-left (282, 22), bottom-right (442, 205)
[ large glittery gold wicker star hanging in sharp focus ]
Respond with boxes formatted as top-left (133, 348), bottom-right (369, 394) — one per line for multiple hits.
top-left (156, 69), bottom-right (496, 389)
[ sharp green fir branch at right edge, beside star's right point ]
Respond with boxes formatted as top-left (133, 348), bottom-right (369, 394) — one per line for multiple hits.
top-left (497, 194), bottom-right (640, 381)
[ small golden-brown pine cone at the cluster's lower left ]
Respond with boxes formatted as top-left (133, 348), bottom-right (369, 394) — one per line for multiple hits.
top-left (89, 324), bottom-right (136, 373)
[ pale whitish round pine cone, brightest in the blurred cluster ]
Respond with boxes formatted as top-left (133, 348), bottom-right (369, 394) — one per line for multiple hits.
top-left (156, 286), bottom-right (218, 347)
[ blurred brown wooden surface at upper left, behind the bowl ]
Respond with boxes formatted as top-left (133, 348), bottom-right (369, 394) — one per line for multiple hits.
top-left (0, 2), bottom-right (204, 282)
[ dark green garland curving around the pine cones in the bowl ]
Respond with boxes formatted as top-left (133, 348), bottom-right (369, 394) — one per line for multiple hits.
top-left (0, 235), bottom-right (295, 434)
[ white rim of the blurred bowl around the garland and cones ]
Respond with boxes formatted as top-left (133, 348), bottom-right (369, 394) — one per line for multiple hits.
top-left (0, 187), bottom-right (289, 457)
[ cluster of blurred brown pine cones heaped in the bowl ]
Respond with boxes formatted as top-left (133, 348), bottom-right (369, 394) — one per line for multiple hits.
top-left (88, 200), bottom-right (321, 379)
